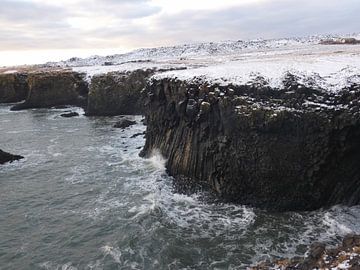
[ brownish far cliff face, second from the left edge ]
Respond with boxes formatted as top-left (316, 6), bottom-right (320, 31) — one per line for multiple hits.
top-left (12, 71), bottom-right (88, 110)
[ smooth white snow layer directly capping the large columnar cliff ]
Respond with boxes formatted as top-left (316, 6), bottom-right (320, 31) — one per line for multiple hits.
top-left (155, 45), bottom-right (360, 92)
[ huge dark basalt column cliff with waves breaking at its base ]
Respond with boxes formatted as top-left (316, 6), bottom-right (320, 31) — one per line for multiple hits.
top-left (141, 75), bottom-right (360, 210)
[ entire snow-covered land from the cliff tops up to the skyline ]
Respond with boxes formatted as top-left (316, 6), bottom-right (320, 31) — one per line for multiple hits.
top-left (46, 34), bottom-right (360, 92)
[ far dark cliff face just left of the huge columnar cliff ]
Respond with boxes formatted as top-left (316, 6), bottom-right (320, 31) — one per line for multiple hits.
top-left (86, 69), bottom-right (154, 116)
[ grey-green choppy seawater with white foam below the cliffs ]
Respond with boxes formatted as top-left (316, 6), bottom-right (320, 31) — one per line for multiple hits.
top-left (0, 105), bottom-right (360, 270)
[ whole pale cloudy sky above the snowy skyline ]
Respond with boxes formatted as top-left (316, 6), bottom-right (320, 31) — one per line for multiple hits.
top-left (0, 0), bottom-right (360, 66)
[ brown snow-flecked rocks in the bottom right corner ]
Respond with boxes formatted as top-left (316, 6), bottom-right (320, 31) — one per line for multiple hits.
top-left (249, 234), bottom-right (360, 270)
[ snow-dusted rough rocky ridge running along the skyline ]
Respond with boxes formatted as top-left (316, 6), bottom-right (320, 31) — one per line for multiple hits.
top-left (46, 35), bottom-right (354, 67)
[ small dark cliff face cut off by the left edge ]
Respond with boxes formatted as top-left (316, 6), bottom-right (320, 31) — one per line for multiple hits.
top-left (0, 73), bottom-right (29, 103)
